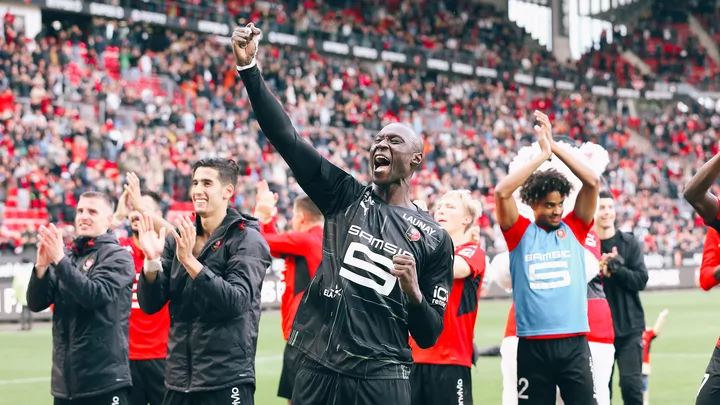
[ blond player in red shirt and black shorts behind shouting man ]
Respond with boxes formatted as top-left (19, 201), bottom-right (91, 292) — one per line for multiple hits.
top-left (410, 190), bottom-right (485, 405)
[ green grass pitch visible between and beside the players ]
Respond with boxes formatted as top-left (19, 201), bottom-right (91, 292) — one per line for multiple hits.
top-left (0, 290), bottom-right (720, 405)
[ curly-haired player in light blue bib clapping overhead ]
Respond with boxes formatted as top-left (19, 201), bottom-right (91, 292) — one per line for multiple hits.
top-left (495, 111), bottom-right (600, 405)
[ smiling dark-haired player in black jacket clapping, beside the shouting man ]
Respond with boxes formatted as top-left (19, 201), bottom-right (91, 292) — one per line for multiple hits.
top-left (138, 158), bottom-right (271, 405)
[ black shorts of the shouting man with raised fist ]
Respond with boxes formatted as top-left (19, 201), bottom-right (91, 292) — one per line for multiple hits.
top-left (291, 356), bottom-right (410, 405)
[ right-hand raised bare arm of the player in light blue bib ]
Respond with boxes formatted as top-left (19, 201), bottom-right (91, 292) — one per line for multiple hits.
top-left (535, 111), bottom-right (600, 224)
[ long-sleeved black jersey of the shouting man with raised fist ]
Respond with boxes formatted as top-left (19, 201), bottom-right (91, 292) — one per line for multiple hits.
top-left (240, 67), bottom-right (454, 379)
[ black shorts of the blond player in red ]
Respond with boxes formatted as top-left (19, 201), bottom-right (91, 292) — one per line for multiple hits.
top-left (410, 364), bottom-right (472, 405)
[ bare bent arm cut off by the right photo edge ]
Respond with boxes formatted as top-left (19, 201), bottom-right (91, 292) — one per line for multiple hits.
top-left (683, 154), bottom-right (720, 226)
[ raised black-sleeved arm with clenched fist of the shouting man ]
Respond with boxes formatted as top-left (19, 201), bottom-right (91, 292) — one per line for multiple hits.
top-left (232, 23), bottom-right (364, 215)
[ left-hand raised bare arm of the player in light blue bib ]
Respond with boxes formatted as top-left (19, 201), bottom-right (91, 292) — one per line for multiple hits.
top-left (495, 121), bottom-right (552, 232)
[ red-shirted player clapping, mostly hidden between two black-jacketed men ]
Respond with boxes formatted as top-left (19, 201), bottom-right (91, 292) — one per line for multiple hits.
top-left (113, 173), bottom-right (170, 405)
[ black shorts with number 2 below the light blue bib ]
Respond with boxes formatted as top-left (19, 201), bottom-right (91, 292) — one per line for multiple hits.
top-left (517, 336), bottom-right (597, 405)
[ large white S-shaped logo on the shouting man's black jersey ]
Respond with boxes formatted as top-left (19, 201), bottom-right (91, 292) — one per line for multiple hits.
top-left (340, 242), bottom-right (397, 296)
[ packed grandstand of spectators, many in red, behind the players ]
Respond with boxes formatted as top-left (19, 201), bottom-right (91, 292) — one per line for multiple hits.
top-left (0, 0), bottom-right (720, 260)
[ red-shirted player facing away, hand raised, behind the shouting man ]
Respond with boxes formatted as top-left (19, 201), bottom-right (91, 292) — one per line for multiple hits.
top-left (254, 181), bottom-right (323, 403)
